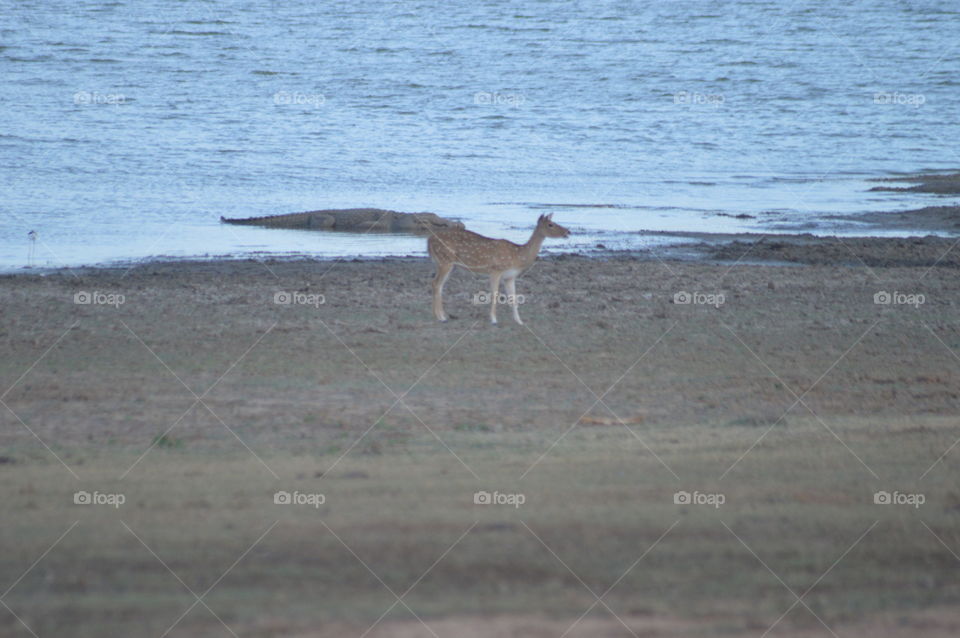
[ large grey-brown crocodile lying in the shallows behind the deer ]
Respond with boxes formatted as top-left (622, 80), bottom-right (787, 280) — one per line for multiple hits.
top-left (220, 208), bottom-right (463, 235)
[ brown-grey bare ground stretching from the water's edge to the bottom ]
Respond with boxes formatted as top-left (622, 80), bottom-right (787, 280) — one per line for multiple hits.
top-left (0, 239), bottom-right (960, 636)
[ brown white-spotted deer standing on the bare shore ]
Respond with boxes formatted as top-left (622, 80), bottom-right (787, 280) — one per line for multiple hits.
top-left (427, 214), bottom-right (570, 325)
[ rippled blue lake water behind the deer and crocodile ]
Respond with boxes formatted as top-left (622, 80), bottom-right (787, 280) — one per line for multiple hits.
top-left (0, 0), bottom-right (960, 270)
